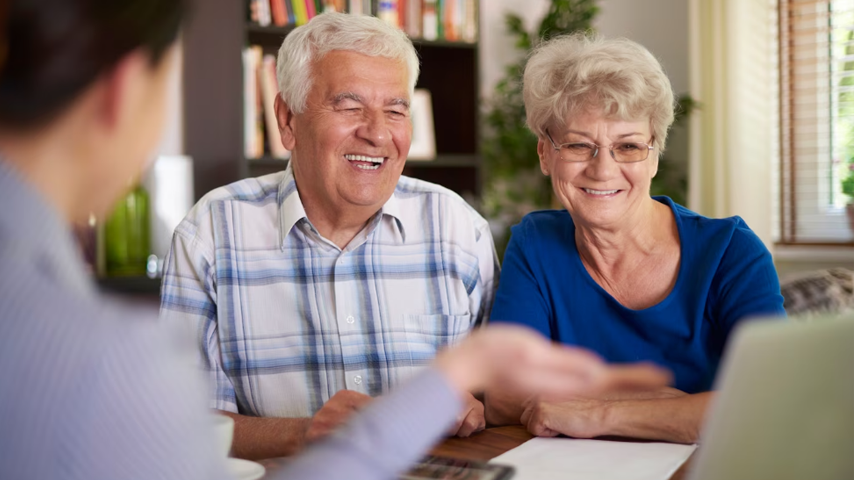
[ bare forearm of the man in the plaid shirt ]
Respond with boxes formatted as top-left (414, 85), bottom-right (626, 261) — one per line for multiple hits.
top-left (219, 411), bottom-right (311, 460)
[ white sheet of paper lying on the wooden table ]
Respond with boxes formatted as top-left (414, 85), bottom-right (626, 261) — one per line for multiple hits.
top-left (492, 438), bottom-right (696, 480)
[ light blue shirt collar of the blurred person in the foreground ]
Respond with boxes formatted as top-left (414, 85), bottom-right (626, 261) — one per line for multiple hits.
top-left (0, 156), bottom-right (96, 296)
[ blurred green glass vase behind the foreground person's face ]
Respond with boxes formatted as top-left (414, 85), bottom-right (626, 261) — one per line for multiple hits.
top-left (104, 185), bottom-right (151, 276)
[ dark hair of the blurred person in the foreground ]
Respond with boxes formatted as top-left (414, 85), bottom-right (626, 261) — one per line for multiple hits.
top-left (0, 0), bottom-right (187, 129)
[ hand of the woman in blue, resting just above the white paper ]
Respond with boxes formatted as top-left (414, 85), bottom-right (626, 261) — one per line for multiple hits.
top-left (521, 398), bottom-right (610, 438)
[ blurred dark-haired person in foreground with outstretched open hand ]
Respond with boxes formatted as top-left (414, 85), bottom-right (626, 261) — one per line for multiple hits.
top-left (0, 0), bottom-right (667, 480)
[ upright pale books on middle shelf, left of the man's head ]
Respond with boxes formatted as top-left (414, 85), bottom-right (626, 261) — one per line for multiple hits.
top-left (243, 45), bottom-right (291, 159)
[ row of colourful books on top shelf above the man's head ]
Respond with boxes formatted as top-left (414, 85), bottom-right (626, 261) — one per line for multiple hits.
top-left (249, 0), bottom-right (478, 42)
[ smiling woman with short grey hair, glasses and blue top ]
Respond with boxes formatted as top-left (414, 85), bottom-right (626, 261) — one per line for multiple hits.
top-left (486, 35), bottom-right (785, 443)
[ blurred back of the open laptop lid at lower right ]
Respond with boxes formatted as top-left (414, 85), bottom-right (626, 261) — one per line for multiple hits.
top-left (688, 314), bottom-right (854, 480)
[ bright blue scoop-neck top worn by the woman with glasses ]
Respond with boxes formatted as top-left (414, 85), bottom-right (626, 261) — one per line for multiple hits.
top-left (490, 197), bottom-right (785, 393)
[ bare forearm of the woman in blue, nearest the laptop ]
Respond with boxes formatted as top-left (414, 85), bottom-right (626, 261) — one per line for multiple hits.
top-left (605, 392), bottom-right (714, 443)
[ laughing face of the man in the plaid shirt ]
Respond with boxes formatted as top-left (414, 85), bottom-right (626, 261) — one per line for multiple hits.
top-left (283, 51), bottom-right (412, 218)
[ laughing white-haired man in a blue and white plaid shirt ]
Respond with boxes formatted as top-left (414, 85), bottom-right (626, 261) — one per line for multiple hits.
top-left (161, 14), bottom-right (498, 458)
